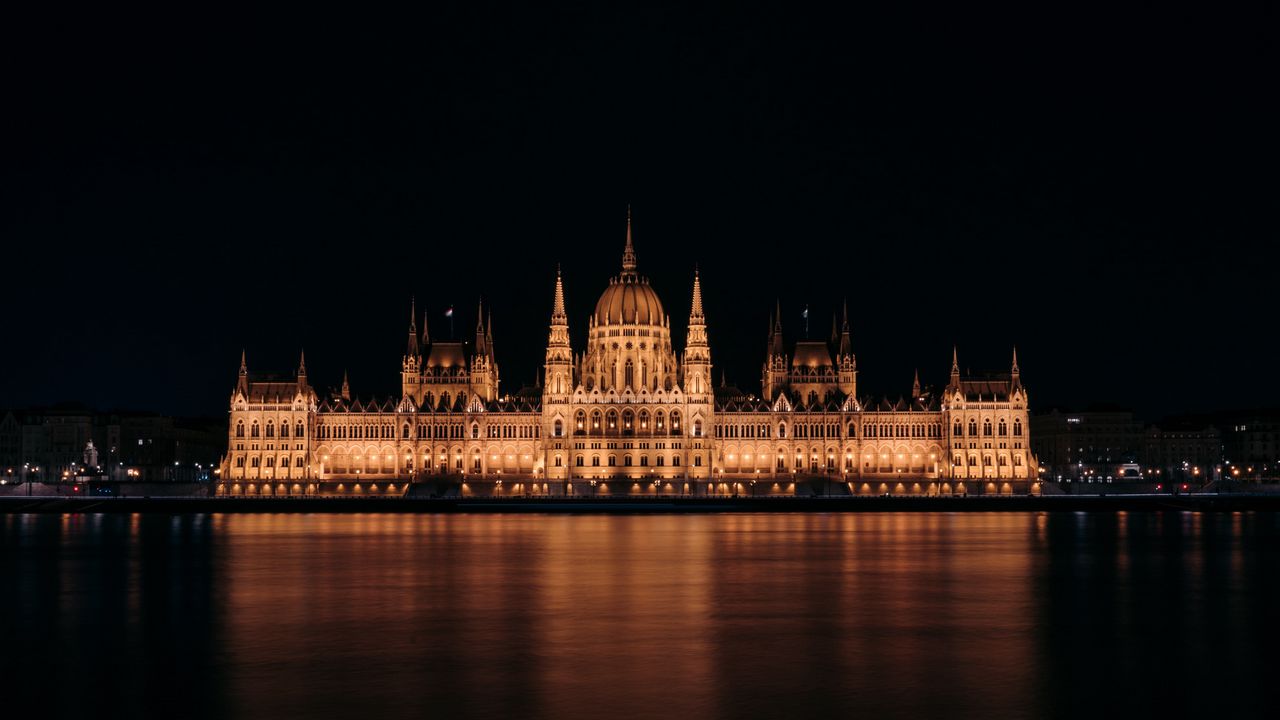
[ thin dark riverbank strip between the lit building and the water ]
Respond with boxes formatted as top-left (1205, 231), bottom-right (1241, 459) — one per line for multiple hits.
top-left (0, 493), bottom-right (1280, 514)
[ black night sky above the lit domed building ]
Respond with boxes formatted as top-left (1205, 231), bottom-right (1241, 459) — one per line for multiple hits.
top-left (0, 4), bottom-right (1280, 416)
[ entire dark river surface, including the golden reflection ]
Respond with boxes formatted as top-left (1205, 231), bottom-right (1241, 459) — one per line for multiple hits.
top-left (0, 512), bottom-right (1280, 719)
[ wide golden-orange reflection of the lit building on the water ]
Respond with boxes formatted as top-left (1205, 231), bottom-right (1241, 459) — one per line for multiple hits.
top-left (214, 514), bottom-right (1037, 717)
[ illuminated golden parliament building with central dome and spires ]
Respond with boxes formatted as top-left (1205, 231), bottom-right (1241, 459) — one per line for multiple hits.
top-left (216, 217), bottom-right (1037, 497)
